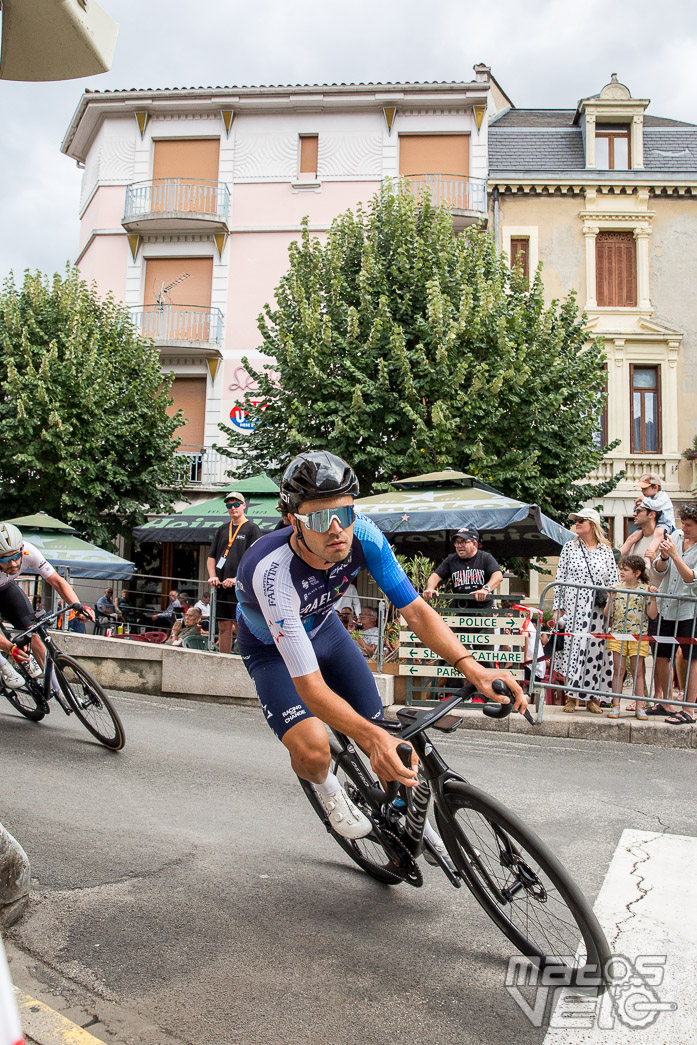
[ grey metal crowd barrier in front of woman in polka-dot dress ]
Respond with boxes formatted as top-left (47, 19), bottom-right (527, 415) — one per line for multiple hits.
top-left (532, 582), bottom-right (697, 718)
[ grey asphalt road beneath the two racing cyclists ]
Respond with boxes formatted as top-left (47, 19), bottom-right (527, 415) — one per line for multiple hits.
top-left (0, 694), bottom-right (697, 1045)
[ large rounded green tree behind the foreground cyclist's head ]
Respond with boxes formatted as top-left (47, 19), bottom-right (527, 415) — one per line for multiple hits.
top-left (220, 185), bottom-right (614, 517)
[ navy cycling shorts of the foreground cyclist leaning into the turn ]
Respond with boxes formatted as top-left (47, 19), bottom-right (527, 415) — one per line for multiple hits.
top-left (237, 613), bottom-right (382, 740)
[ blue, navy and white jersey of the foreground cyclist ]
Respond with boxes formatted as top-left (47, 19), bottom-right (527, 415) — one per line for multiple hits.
top-left (235, 514), bottom-right (418, 678)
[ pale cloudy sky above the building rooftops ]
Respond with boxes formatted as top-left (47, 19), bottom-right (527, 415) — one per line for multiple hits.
top-left (0, 0), bottom-right (697, 279)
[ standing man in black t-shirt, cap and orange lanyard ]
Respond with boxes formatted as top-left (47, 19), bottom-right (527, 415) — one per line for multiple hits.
top-left (207, 491), bottom-right (261, 653)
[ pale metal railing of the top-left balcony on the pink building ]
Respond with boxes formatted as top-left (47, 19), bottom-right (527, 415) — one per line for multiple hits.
top-left (123, 178), bottom-right (230, 225)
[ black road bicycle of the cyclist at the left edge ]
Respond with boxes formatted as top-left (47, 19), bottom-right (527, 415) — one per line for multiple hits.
top-left (1, 603), bottom-right (125, 751)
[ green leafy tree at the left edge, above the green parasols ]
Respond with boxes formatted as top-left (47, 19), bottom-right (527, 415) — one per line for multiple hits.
top-left (0, 269), bottom-right (182, 542)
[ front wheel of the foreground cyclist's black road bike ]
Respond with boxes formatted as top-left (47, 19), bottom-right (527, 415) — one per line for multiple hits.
top-left (436, 782), bottom-right (610, 993)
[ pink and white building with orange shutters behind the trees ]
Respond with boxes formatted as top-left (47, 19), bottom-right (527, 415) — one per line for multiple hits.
top-left (62, 66), bottom-right (510, 492)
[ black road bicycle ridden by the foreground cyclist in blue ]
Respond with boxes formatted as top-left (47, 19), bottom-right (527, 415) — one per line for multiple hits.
top-left (300, 680), bottom-right (610, 995)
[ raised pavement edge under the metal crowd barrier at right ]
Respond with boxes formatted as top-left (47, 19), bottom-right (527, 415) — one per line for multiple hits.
top-left (385, 701), bottom-right (697, 748)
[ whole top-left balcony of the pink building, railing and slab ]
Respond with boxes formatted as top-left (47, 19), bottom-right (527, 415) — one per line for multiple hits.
top-left (121, 178), bottom-right (230, 233)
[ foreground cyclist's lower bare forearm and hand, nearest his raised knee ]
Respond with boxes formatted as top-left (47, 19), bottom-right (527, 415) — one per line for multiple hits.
top-left (293, 671), bottom-right (417, 786)
